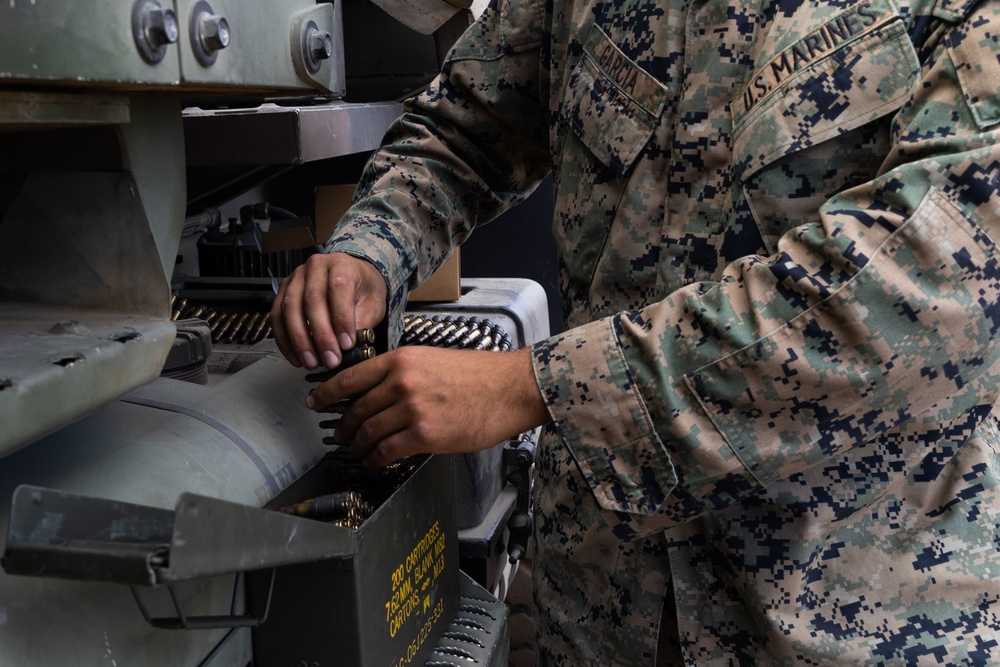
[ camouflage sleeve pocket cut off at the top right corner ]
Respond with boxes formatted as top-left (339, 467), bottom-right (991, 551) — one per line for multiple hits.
top-left (945, 3), bottom-right (1000, 129)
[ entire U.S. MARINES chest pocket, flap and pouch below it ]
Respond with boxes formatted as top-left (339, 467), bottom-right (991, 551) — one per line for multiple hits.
top-left (732, 0), bottom-right (920, 252)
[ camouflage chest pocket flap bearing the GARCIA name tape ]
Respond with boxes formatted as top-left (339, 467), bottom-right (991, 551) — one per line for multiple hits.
top-left (560, 26), bottom-right (667, 173)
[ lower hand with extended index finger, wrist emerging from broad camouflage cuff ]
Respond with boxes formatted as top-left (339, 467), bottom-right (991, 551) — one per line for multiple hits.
top-left (307, 346), bottom-right (549, 468)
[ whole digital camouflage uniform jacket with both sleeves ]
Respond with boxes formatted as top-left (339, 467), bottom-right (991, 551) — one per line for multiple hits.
top-left (329, 0), bottom-right (1000, 665)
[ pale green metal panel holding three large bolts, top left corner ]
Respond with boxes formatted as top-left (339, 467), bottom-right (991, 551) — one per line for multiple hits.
top-left (0, 0), bottom-right (344, 96)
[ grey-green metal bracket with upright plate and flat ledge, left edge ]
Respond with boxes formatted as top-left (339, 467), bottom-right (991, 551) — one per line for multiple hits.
top-left (0, 93), bottom-right (186, 455)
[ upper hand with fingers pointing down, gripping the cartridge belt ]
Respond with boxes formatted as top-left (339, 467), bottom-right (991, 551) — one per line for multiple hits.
top-left (271, 253), bottom-right (387, 369)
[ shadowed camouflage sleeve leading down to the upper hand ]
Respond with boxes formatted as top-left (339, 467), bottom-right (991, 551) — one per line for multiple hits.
top-left (326, 0), bottom-right (551, 340)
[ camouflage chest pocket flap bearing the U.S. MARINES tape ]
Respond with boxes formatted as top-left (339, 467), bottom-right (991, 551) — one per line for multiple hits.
top-left (732, 0), bottom-right (920, 181)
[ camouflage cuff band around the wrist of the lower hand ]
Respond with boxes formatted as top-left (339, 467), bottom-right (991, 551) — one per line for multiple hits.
top-left (532, 319), bottom-right (677, 515)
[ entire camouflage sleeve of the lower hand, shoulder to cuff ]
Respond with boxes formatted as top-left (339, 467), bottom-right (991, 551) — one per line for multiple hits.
top-left (534, 2), bottom-right (1000, 539)
